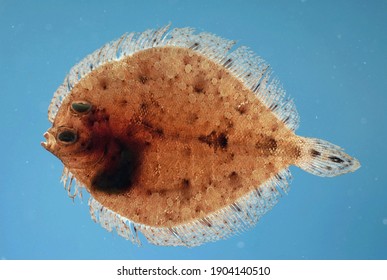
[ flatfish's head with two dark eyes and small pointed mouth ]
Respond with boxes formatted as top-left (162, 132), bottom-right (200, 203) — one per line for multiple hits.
top-left (41, 101), bottom-right (108, 169)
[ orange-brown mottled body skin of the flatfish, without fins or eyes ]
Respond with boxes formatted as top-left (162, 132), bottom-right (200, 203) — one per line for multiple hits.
top-left (42, 47), bottom-right (303, 227)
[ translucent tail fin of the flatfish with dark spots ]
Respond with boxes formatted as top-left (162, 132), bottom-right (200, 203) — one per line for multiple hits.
top-left (297, 138), bottom-right (360, 177)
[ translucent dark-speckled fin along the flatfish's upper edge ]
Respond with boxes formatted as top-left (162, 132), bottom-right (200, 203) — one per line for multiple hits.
top-left (48, 25), bottom-right (299, 131)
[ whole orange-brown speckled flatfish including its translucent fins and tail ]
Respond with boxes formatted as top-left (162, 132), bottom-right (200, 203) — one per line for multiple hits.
top-left (42, 26), bottom-right (360, 246)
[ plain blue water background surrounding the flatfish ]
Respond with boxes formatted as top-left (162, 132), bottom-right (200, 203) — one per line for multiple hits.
top-left (0, 0), bottom-right (387, 259)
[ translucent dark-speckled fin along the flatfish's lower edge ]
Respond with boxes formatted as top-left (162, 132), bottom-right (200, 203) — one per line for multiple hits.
top-left (89, 169), bottom-right (291, 247)
